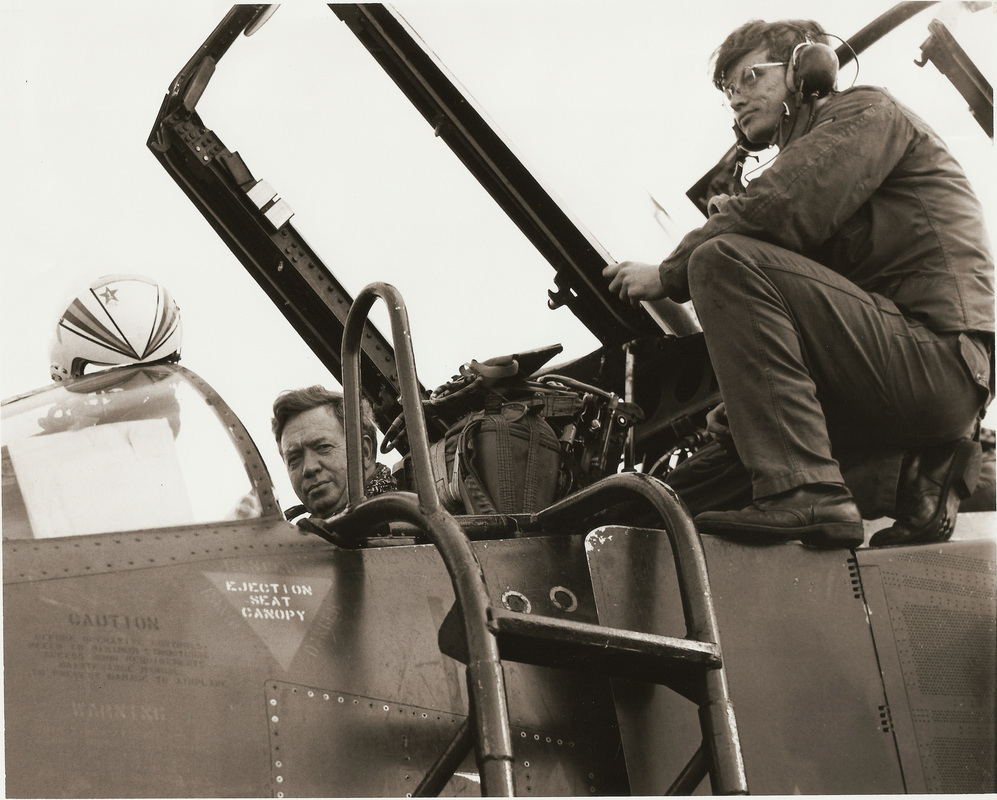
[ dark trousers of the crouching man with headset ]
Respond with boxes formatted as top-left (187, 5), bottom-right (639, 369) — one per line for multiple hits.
top-left (670, 235), bottom-right (990, 510)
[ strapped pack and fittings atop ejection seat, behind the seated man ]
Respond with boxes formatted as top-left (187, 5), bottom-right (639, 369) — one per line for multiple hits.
top-left (381, 345), bottom-right (643, 514)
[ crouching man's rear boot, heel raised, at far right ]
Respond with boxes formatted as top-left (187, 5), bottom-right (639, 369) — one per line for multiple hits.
top-left (869, 438), bottom-right (983, 547)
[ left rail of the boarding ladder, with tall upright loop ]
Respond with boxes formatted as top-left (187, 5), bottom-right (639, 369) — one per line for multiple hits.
top-left (340, 283), bottom-right (515, 797)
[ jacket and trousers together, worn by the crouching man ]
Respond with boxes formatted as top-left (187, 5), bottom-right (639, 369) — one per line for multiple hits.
top-left (660, 87), bottom-right (994, 510)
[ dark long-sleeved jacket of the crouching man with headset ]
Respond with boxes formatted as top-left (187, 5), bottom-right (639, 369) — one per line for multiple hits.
top-left (660, 86), bottom-right (994, 333)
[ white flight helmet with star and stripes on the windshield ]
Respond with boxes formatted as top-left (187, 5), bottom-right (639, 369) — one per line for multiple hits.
top-left (49, 275), bottom-right (183, 381)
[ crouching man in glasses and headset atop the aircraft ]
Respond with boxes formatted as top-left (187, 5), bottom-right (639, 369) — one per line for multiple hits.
top-left (604, 20), bottom-right (994, 547)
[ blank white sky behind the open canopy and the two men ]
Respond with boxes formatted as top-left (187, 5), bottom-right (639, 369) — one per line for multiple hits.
top-left (0, 0), bottom-right (997, 506)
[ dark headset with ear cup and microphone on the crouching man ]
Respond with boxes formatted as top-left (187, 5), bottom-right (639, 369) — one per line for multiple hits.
top-left (734, 31), bottom-right (838, 185)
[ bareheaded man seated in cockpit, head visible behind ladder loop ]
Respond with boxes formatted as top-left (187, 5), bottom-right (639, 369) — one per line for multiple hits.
top-left (272, 386), bottom-right (398, 519)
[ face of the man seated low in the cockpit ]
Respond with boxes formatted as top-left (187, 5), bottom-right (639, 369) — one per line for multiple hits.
top-left (280, 406), bottom-right (347, 518)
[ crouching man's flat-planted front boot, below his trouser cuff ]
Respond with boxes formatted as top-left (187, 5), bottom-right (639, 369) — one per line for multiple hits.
top-left (694, 483), bottom-right (865, 549)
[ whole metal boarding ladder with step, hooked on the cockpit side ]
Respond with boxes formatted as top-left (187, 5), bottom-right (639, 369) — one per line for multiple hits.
top-left (317, 283), bottom-right (748, 796)
